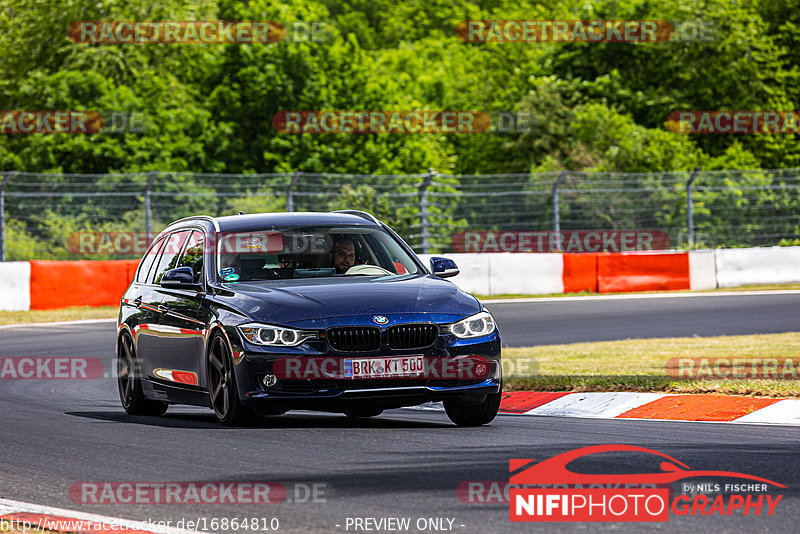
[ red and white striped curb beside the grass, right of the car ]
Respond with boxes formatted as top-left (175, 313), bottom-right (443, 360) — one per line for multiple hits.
top-left (421, 391), bottom-right (800, 425)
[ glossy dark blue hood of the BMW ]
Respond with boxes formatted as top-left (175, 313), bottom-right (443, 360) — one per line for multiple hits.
top-left (211, 275), bottom-right (481, 325)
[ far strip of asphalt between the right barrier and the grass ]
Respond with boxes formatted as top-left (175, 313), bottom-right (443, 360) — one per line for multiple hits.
top-left (486, 291), bottom-right (800, 347)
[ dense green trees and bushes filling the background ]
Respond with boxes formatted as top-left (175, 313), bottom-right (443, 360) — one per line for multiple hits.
top-left (0, 0), bottom-right (800, 255)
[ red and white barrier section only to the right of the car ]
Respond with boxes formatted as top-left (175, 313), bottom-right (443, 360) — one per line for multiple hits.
top-left (428, 247), bottom-right (800, 295)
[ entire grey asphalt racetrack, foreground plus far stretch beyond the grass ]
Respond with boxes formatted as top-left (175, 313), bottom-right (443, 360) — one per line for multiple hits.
top-left (0, 294), bottom-right (800, 533)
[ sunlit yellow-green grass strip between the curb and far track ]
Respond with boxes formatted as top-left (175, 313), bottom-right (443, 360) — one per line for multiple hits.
top-left (503, 332), bottom-right (800, 397)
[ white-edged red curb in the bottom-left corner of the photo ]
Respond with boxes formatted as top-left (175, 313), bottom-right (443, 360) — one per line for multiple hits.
top-left (0, 499), bottom-right (196, 534)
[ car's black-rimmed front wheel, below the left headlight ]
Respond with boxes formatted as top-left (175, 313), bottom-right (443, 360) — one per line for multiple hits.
top-left (208, 333), bottom-right (261, 426)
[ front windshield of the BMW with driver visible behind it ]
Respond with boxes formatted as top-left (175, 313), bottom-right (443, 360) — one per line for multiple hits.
top-left (217, 226), bottom-right (419, 282)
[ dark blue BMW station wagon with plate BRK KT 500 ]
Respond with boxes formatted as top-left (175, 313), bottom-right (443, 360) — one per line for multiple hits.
top-left (116, 211), bottom-right (502, 426)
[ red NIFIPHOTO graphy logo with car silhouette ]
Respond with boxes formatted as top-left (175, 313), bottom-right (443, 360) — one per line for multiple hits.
top-left (509, 445), bottom-right (786, 522)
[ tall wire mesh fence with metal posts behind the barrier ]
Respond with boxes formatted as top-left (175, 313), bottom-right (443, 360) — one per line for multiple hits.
top-left (0, 169), bottom-right (800, 261)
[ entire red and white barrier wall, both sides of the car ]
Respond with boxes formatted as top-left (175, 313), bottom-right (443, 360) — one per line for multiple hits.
top-left (0, 247), bottom-right (800, 311)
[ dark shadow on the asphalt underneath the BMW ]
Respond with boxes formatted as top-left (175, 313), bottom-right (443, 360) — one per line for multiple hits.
top-left (65, 411), bottom-right (453, 430)
